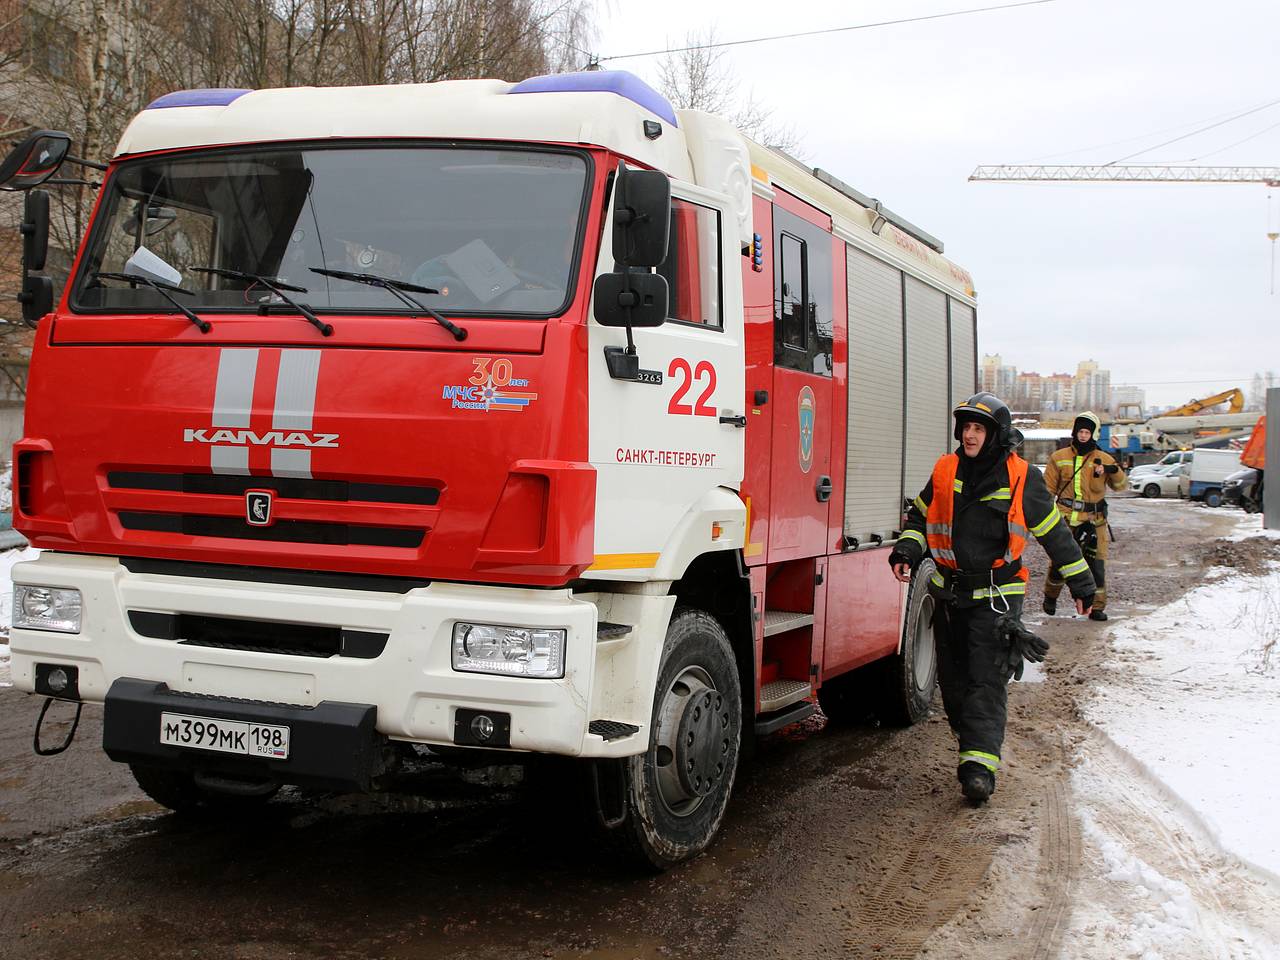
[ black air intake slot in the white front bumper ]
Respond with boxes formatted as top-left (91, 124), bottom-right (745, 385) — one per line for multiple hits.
top-left (129, 611), bottom-right (389, 660)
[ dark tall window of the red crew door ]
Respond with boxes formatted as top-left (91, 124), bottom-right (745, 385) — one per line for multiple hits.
top-left (773, 206), bottom-right (836, 376)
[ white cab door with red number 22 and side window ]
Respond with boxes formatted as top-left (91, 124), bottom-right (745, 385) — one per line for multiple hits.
top-left (588, 180), bottom-right (746, 579)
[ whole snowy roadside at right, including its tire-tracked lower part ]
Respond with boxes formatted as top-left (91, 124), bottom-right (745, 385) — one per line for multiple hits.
top-left (1066, 515), bottom-right (1280, 960)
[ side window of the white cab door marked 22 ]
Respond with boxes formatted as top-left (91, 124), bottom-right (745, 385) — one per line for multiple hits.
top-left (658, 197), bottom-right (723, 328)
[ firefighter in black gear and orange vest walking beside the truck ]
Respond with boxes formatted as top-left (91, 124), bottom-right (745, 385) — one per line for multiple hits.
top-left (888, 393), bottom-right (1094, 803)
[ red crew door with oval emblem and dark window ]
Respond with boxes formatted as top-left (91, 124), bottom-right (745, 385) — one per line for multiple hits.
top-left (768, 197), bottom-right (835, 563)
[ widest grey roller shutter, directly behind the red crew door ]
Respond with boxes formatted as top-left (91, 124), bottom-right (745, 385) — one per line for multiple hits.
top-left (845, 247), bottom-right (914, 543)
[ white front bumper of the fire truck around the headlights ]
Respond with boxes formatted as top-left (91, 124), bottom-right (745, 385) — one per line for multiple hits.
top-left (10, 552), bottom-right (646, 756)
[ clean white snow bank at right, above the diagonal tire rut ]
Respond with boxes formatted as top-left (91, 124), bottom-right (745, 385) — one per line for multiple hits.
top-left (1087, 563), bottom-right (1280, 877)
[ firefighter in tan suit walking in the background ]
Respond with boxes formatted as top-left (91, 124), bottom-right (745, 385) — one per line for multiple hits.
top-left (1044, 411), bottom-right (1125, 620)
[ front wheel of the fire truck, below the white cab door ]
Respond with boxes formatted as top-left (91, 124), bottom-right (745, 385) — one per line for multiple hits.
top-left (607, 609), bottom-right (742, 870)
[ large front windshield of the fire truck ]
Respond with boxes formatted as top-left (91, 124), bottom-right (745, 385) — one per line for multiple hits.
top-left (72, 145), bottom-right (588, 316)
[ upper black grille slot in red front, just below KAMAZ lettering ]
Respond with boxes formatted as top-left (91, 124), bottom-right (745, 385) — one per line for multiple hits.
top-left (106, 470), bottom-right (440, 507)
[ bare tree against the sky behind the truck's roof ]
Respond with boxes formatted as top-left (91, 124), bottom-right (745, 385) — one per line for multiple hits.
top-left (658, 27), bottom-right (804, 157)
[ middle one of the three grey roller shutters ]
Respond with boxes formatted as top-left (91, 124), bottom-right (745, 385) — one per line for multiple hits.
top-left (904, 276), bottom-right (952, 497)
